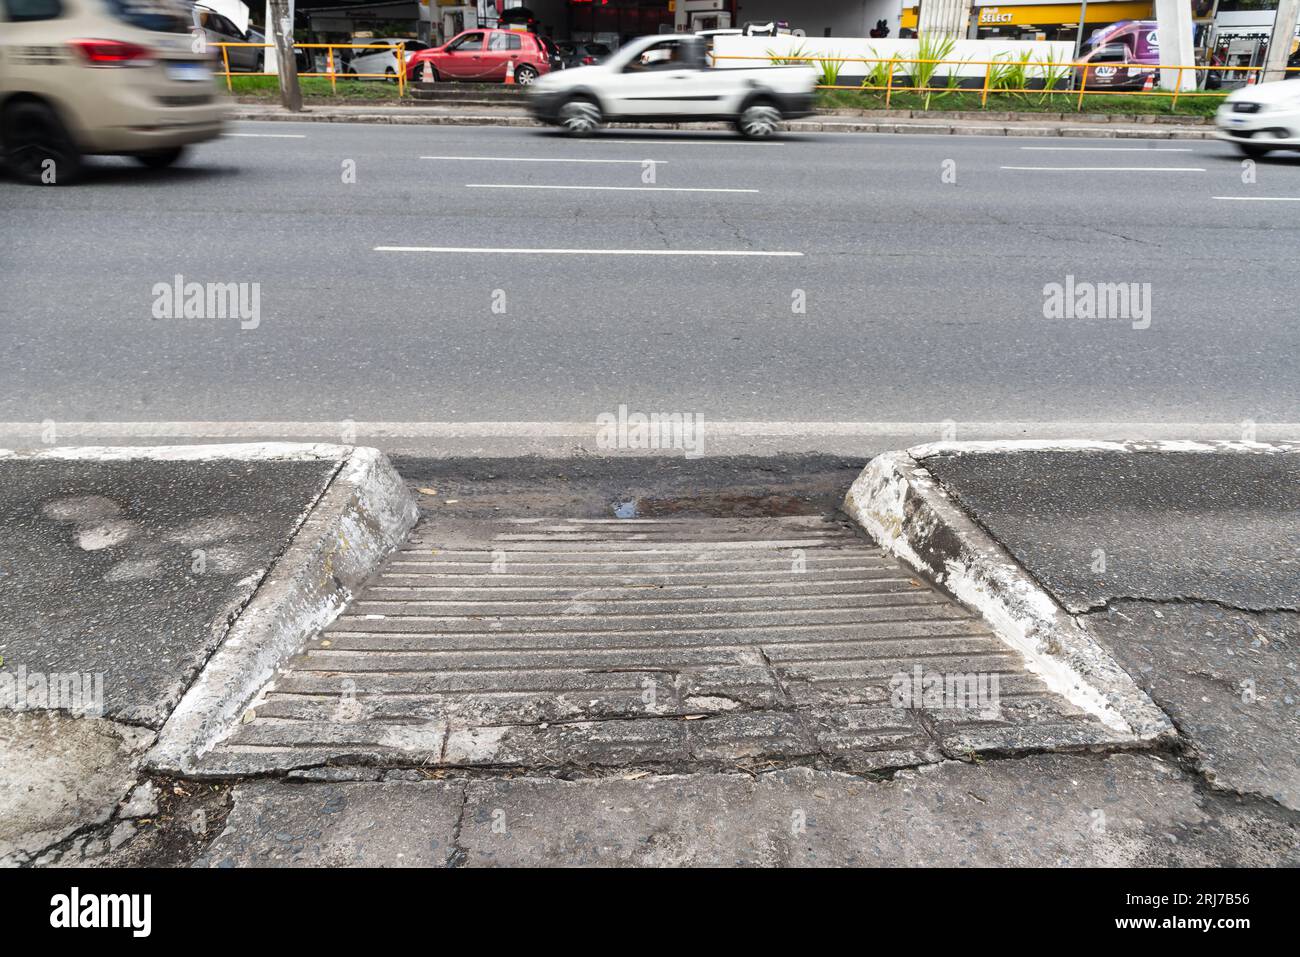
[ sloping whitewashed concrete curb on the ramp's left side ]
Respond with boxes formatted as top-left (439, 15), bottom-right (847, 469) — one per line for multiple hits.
top-left (144, 446), bottom-right (419, 774)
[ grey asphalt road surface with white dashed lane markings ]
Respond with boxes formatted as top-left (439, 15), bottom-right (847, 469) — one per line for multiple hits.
top-left (0, 122), bottom-right (1300, 437)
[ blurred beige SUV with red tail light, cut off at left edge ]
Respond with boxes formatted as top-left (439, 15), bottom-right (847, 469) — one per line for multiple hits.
top-left (0, 0), bottom-right (225, 185)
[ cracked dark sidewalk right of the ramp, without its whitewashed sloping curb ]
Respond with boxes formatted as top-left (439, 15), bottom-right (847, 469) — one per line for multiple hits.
top-left (923, 443), bottom-right (1300, 810)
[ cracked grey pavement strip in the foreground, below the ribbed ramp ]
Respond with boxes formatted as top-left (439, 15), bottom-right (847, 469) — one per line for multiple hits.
top-left (198, 754), bottom-right (1300, 867)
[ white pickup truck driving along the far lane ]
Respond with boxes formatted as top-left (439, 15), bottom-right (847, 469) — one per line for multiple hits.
top-left (528, 34), bottom-right (816, 138)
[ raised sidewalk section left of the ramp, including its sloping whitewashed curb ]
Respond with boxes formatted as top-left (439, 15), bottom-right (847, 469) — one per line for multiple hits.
top-left (0, 443), bottom-right (416, 865)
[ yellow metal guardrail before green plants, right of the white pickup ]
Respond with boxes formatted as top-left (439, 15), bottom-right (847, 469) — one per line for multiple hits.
top-left (714, 53), bottom-right (1300, 111)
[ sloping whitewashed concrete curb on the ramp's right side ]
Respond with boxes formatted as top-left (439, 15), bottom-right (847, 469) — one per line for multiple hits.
top-left (844, 442), bottom-right (1174, 742)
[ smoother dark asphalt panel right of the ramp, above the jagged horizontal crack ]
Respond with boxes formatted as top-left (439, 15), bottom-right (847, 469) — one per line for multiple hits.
top-left (913, 443), bottom-right (1300, 614)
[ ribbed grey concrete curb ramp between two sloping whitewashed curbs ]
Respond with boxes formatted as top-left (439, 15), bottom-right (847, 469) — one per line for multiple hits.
top-left (208, 516), bottom-right (1106, 770)
